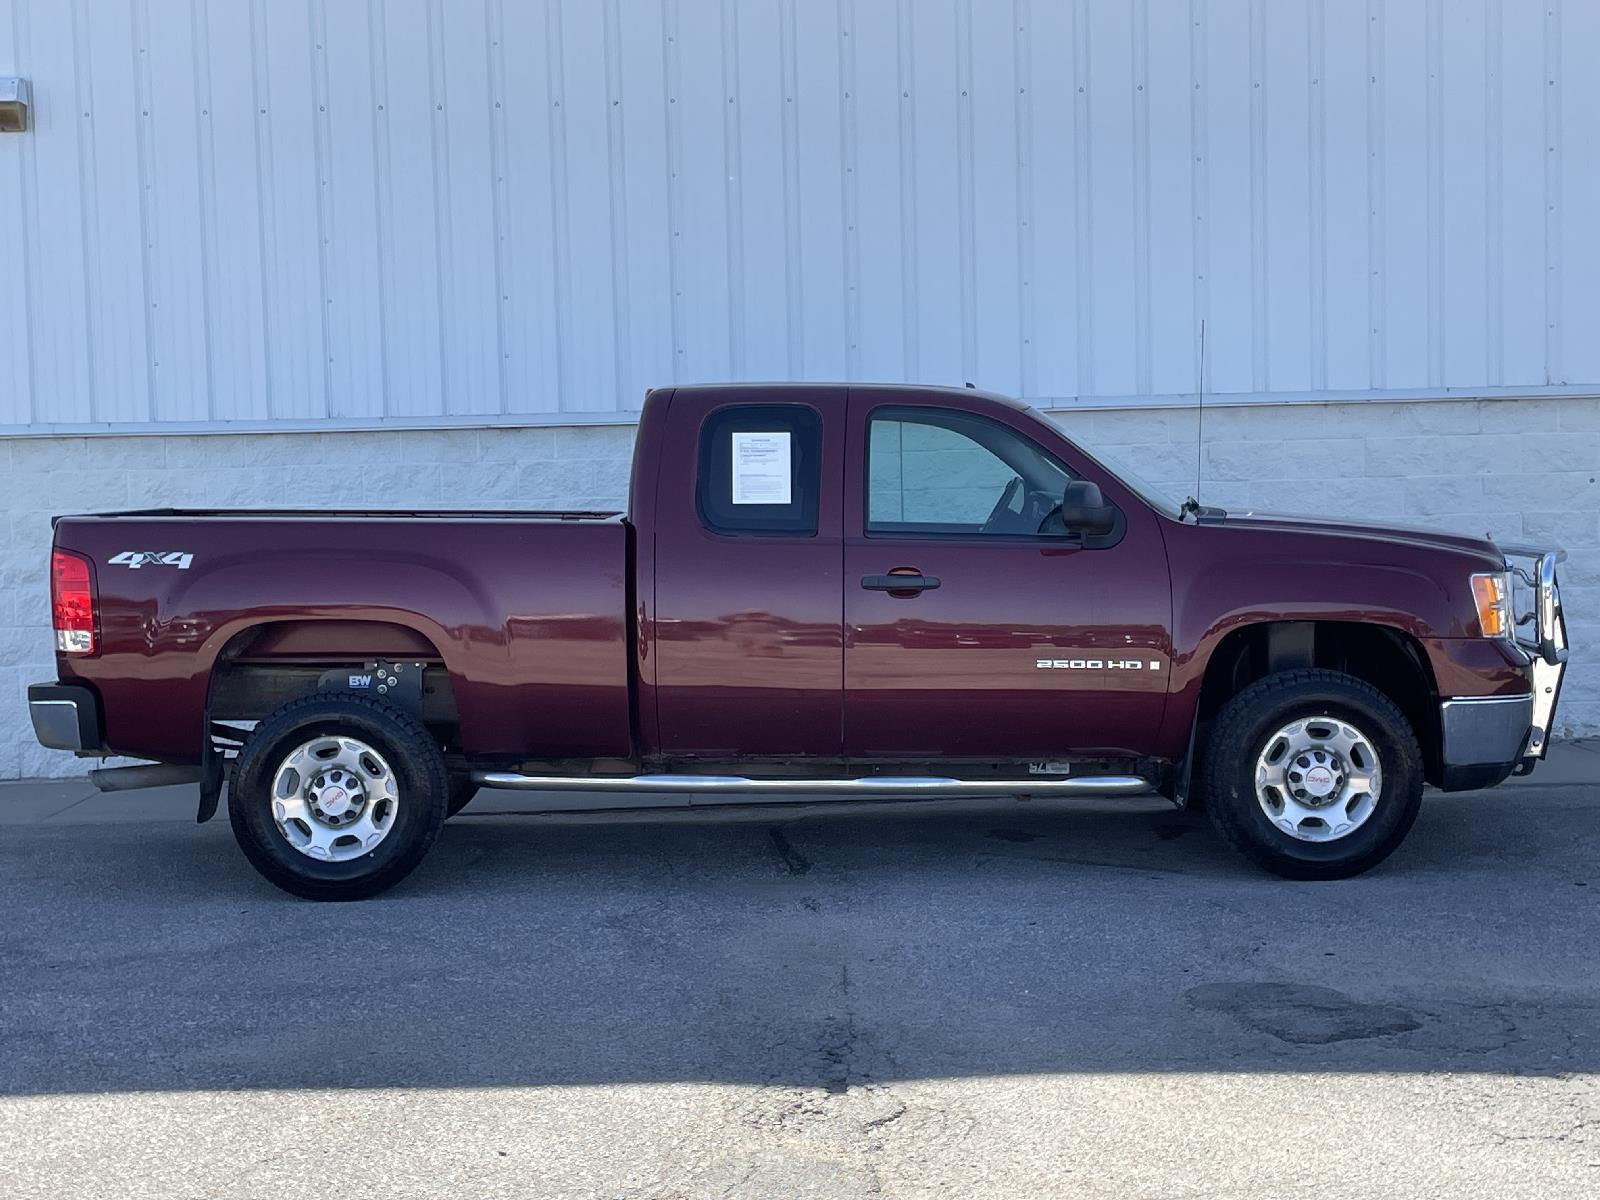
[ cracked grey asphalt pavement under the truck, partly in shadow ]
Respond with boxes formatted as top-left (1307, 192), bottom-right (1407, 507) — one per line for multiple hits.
top-left (0, 776), bottom-right (1600, 1200)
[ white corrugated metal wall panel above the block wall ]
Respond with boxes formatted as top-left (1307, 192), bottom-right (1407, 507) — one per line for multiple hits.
top-left (0, 0), bottom-right (1600, 432)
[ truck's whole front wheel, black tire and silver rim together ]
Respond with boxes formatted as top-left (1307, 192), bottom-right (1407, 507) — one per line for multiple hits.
top-left (1202, 669), bottom-right (1422, 880)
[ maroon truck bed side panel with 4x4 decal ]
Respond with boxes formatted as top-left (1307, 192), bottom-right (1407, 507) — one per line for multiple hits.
top-left (56, 509), bottom-right (632, 762)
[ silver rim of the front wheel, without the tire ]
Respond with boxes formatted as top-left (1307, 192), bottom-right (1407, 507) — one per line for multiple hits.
top-left (1256, 717), bottom-right (1384, 842)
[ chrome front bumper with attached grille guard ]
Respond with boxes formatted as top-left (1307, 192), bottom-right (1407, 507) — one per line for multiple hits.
top-left (1438, 546), bottom-right (1566, 792)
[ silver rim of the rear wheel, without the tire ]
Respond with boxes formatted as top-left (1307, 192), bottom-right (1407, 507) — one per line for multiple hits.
top-left (272, 734), bottom-right (400, 862)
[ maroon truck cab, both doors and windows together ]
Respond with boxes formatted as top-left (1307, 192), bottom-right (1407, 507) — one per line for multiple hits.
top-left (634, 386), bottom-right (1173, 774)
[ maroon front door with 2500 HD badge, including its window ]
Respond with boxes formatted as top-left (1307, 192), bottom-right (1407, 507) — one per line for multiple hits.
top-left (845, 400), bottom-right (1171, 762)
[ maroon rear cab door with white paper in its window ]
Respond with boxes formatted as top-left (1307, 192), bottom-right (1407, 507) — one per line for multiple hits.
top-left (635, 386), bottom-right (845, 766)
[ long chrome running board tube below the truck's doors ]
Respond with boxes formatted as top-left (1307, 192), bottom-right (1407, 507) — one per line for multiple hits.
top-left (472, 771), bottom-right (1155, 800)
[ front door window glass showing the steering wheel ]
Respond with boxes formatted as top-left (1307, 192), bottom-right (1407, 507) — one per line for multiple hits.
top-left (867, 408), bottom-right (1072, 536)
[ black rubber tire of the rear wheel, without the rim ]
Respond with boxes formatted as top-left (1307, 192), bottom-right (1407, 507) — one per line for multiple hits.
top-left (227, 694), bottom-right (450, 901)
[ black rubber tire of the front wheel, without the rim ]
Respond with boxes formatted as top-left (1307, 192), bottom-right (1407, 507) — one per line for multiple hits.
top-left (1202, 669), bottom-right (1422, 880)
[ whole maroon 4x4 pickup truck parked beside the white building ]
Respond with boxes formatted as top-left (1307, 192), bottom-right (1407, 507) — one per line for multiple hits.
top-left (29, 384), bottom-right (1566, 899)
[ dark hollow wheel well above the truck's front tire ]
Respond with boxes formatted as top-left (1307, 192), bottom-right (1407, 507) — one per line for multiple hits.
top-left (1197, 621), bottom-right (1440, 782)
